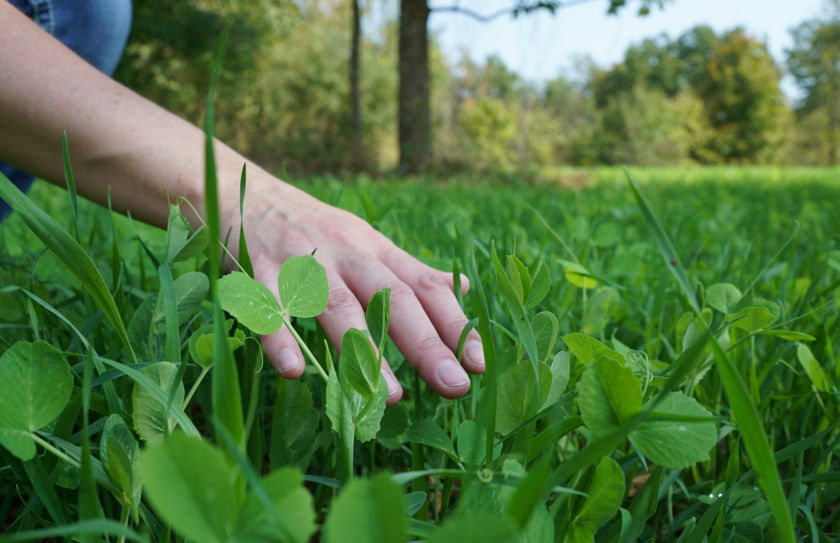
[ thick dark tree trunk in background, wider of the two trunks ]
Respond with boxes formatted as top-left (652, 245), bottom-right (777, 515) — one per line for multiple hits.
top-left (399, 0), bottom-right (432, 173)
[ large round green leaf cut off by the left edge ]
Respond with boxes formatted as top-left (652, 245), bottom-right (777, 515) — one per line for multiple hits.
top-left (0, 341), bottom-right (73, 460)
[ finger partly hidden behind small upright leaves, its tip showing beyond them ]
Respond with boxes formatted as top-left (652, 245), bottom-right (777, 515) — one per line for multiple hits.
top-left (318, 268), bottom-right (402, 405)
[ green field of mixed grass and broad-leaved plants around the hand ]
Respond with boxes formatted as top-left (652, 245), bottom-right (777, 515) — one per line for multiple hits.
top-left (0, 168), bottom-right (840, 543)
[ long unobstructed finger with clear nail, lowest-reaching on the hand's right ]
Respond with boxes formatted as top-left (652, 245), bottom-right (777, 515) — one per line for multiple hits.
top-left (342, 261), bottom-right (470, 398)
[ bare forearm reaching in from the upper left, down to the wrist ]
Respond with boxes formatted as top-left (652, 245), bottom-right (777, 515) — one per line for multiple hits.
top-left (0, 2), bottom-right (308, 236)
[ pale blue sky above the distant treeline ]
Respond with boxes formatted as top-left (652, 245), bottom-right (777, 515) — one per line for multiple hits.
top-left (372, 0), bottom-right (823, 98)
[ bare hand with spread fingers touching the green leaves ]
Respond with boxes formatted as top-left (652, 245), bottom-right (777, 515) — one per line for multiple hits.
top-left (236, 176), bottom-right (484, 405)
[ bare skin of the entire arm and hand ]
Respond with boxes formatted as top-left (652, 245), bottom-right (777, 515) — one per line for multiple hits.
top-left (0, 1), bottom-right (484, 404)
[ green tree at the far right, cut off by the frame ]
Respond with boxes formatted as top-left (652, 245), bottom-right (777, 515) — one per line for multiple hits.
top-left (786, 0), bottom-right (840, 165)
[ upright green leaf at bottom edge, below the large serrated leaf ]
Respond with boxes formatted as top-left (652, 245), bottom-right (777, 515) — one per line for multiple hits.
top-left (568, 456), bottom-right (624, 542)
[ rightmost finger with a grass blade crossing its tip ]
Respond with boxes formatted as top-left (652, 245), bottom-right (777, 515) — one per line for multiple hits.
top-left (386, 249), bottom-right (485, 373)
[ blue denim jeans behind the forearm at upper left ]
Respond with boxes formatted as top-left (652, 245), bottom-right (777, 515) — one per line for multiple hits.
top-left (0, 0), bottom-right (131, 221)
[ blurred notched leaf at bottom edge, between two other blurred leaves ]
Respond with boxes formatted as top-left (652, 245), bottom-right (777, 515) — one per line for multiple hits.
top-left (234, 468), bottom-right (315, 543)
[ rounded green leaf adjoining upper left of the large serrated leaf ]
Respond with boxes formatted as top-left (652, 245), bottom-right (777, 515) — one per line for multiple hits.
top-left (577, 357), bottom-right (642, 436)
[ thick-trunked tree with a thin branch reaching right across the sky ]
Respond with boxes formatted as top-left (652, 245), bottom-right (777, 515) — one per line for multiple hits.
top-left (398, 0), bottom-right (666, 173)
